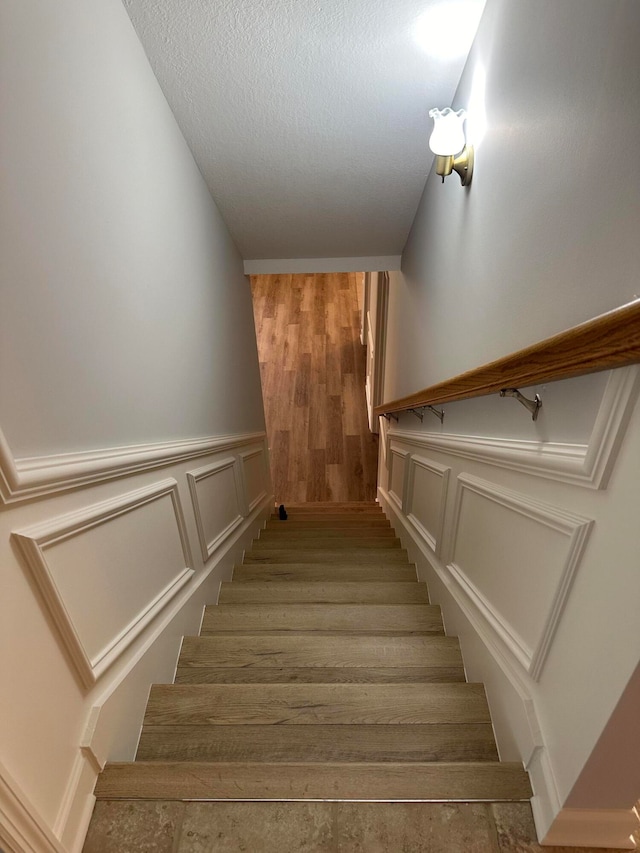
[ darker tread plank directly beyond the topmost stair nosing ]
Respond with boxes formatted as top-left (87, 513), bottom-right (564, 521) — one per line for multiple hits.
top-left (136, 723), bottom-right (498, 761)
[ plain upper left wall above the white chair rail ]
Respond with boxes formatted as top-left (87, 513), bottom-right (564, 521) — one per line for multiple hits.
top-left (0, 0), bottom-right (264, 457)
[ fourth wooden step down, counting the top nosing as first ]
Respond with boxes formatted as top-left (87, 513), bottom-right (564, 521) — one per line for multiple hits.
top-left (200, 604), bottom-right (444, 636)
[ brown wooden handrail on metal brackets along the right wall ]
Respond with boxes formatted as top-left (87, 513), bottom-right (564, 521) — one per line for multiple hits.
top-left (374, 299), bottom-right (640, 417)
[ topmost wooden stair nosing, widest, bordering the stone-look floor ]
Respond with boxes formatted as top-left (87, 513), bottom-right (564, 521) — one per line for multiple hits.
top-left (94, 761), bottom-right (531, 802)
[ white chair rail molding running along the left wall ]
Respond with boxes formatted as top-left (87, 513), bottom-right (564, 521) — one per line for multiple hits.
top-left (0, 429), bottom-right (265, 504)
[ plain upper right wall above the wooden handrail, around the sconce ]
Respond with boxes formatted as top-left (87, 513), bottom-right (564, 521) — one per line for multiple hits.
top-left (385, 0), bottom-right (640, 399)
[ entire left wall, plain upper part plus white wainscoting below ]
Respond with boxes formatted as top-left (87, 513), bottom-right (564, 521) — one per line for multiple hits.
top-left (0, 0), bottom-right (271, 853)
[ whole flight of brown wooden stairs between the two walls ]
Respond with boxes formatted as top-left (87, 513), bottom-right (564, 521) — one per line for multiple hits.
top-left (90, 503), bottom-right (531, 849)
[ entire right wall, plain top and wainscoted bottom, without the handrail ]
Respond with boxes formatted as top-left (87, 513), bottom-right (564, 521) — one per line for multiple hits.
top-left (381, 0), bottom-right (640, 846)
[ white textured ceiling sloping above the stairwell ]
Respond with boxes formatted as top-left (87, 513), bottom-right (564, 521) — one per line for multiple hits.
top-left (124, 0), bottom-right (484, 259)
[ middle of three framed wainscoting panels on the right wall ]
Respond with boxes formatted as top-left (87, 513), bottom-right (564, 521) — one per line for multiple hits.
top-left (405, 456), bottom-right (451, 554)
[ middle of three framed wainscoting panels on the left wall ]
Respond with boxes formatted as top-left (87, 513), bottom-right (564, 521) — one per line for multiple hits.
top-left (187, 456), bottom-right (245, 563)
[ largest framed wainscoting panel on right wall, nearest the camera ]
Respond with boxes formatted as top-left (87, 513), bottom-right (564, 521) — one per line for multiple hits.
top-left (447, 474), bottom-right (593, 679)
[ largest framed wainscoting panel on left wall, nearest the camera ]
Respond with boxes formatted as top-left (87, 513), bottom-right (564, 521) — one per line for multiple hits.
top-left (12, 479), bottom-right (193, 687)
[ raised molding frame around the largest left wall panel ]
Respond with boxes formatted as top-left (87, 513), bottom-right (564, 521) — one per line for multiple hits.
top-left (12, 478), bottom-right (194, 688)
